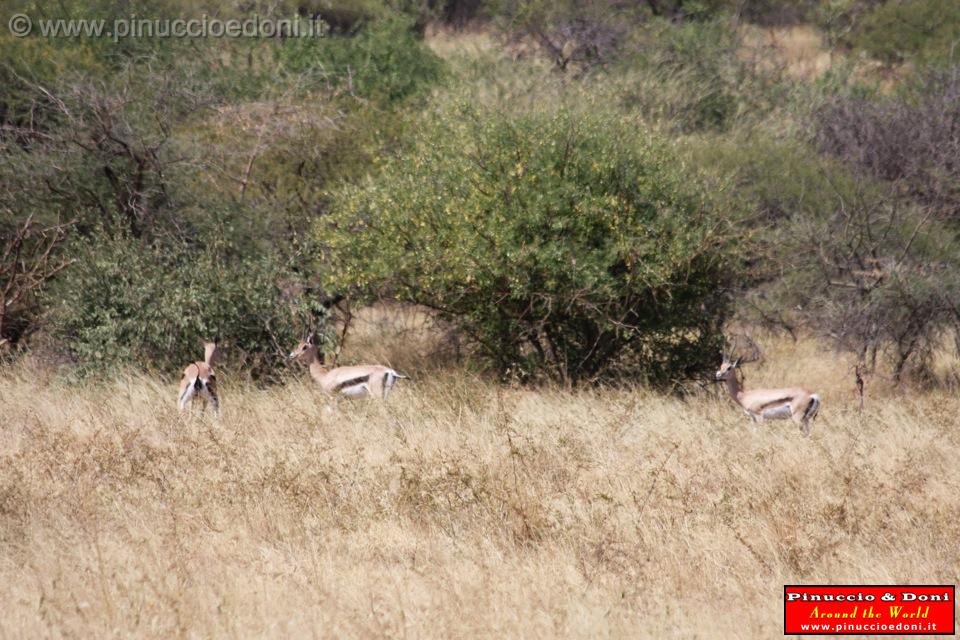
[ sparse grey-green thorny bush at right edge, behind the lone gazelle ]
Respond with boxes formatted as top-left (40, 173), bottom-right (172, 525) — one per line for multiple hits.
top-left (689, 127), bottom-right (960, 381)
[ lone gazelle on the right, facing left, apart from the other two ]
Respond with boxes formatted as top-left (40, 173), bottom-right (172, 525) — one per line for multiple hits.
top-left (716, 354), bottom-right (820, 436)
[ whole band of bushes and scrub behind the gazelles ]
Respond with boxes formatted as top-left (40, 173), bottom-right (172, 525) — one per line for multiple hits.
top-left (0, 0), bottom-right (960, 385)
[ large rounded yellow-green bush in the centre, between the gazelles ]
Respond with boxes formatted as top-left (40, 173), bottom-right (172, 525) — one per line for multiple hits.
top-left (317, 109), bottom-right (738, 384)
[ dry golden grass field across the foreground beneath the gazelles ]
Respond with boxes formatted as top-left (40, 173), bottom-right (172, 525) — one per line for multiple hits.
top-left (0, 342), bottom-right (960, 638)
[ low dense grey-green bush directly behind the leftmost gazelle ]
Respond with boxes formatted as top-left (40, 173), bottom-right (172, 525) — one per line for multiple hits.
top-left (47, 234), bottom-right (332, 379)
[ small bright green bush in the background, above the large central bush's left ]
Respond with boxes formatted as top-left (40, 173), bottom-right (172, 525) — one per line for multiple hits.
top-left (278, 15), bottom-right (443, 103)
